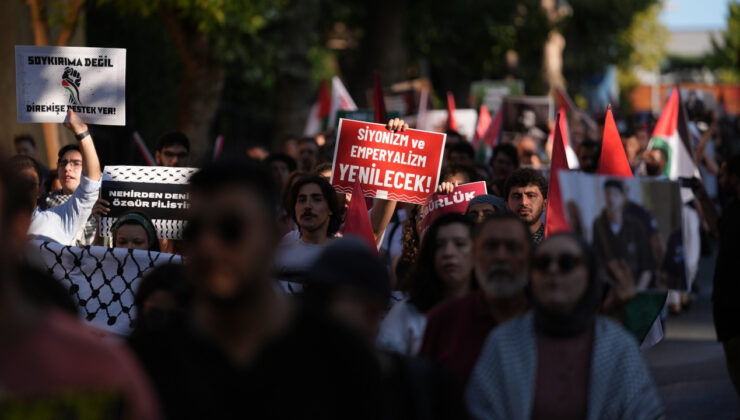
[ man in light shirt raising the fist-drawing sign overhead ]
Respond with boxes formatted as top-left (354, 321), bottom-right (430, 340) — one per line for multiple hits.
top-left (21, 110), bottom-right (101, 245)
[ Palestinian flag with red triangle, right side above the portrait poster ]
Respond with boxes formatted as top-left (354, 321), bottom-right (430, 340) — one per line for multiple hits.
top-left (648, 87), bottom-right (700, 180)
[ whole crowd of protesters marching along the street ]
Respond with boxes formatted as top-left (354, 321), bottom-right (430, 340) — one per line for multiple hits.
top-left (0, 96), bottom-right (740, 419)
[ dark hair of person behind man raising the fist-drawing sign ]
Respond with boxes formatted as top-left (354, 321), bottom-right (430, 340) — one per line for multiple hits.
top-left (2, 155), bottom-right (43, 218)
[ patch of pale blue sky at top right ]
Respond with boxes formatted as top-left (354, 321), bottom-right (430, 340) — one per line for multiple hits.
top-left (660, 0), bottom-right (737, 29)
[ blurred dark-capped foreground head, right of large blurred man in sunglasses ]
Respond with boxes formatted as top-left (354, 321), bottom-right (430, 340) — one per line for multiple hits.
top-left (304, 236), bottom-right (391, 342)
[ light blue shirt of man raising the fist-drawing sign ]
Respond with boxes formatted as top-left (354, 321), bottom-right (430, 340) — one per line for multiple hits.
top-left (28, 175), bottom-right (100, 245)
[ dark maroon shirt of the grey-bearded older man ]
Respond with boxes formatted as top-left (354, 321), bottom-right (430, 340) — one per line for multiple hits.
top-left (420, 290), bottom-right (498, 387)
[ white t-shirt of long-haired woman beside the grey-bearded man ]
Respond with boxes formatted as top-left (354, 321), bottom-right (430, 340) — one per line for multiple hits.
top-left (378, 300), bottom-right (427, 357)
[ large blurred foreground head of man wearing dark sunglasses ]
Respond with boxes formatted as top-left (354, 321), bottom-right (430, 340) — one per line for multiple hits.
top-left (184, 161), bottom-right (278, 304)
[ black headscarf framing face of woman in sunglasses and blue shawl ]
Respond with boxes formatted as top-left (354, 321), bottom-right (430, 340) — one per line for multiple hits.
top-left (533, 233), bottom-right (602, 338)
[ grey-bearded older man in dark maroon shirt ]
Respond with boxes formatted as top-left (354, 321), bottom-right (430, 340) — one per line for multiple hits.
top-left (420, 214), bottom-right (532, 387)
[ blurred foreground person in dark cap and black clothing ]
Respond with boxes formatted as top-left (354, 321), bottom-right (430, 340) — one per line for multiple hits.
top-left (292, 237), bottom-right (465, 419)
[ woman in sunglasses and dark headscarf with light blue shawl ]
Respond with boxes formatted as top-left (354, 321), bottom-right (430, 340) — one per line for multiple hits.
top-left (466, 234), bottom-right (663, 419)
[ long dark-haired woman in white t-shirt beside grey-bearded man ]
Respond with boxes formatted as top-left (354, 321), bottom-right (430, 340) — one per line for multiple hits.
top-left (378, 214), bottom-right (474, 356)
